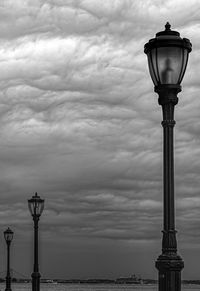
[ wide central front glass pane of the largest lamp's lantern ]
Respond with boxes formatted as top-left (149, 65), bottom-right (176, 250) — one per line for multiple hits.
top-left (157, 47), bottom-right (183, 84)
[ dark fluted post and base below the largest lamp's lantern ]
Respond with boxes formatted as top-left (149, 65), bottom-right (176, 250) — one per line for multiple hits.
top-left (155, 85), bottom-right (184, 291)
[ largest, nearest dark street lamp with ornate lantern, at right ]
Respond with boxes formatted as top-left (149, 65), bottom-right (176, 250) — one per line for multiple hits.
top-left (144, 22), bottom-right (192, 291)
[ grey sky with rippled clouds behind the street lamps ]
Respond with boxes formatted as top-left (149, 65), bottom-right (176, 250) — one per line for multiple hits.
top-left (0, 0), bottom-right (200, 279)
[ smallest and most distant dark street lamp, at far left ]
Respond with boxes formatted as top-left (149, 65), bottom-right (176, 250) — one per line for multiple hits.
top-left (4, 227), bottom-right (14, 291)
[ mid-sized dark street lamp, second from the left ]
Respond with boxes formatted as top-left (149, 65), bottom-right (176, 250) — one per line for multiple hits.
top-left (28, 193), bottom-right (44, 291)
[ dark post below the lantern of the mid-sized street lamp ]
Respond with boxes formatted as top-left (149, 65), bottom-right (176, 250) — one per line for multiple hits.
top-left (32, 217), bottom-right (40, 291)
